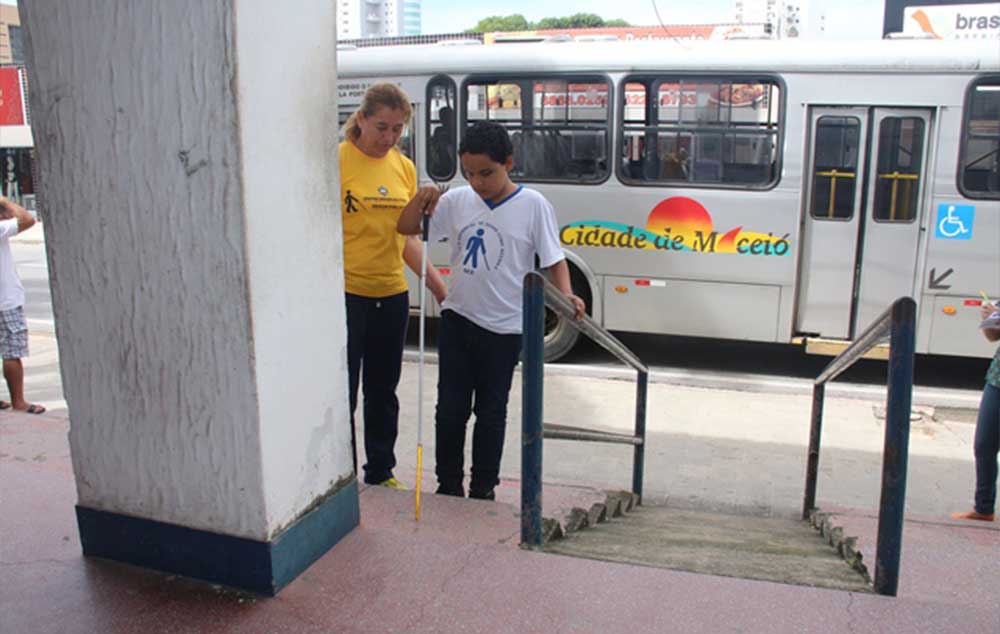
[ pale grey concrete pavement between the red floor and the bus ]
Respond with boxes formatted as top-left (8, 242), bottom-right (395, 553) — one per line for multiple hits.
top-left (388, 363), bottom-right (975, 516)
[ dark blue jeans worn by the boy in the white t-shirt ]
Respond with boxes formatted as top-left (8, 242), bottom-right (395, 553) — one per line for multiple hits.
top-left (435, 310), bottom-right (521, 495)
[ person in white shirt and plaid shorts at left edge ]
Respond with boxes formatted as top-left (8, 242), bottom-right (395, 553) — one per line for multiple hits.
top-left (0, 197), bottom-right (45, 414)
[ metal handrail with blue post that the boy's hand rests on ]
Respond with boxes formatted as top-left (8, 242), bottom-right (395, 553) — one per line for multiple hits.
top-left (521, 271), bottom-right (649, 548)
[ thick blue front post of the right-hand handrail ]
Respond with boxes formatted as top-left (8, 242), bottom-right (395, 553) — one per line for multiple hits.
top-left (874, 298), bottom-right (916, 597)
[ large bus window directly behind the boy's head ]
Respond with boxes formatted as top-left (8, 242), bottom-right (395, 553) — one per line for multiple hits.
top-left (465, 76), bottom-right (610, 183)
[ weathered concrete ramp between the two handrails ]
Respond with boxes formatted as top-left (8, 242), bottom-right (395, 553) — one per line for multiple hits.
top-left (545, 506), bottom-right (872, 592)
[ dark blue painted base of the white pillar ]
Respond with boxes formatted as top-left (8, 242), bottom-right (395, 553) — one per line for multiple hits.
top-left (76, 478), bottom-right (360, 596)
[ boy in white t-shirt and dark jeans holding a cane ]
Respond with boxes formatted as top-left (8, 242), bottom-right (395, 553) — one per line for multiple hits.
top-left (397, 122), bottom-right (586, 500)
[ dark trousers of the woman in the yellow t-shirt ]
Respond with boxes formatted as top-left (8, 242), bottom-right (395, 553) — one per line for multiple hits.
top-left (345, 292), bottom-right (410, 484)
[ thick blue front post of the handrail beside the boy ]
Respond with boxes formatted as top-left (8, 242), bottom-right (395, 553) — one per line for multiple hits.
top-left (521, 273), bottom-right (545, 548)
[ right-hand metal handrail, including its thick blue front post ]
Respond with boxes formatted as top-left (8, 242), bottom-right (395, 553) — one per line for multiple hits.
top-left (802, 297), bottom-right (917, 596)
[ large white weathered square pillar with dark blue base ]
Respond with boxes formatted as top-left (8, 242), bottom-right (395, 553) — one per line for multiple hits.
top-left (21, 0), bottom-right (358, 594)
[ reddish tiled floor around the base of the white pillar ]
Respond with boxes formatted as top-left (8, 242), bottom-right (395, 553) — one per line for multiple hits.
top-left (0, 413), bottom-right (1000, 634)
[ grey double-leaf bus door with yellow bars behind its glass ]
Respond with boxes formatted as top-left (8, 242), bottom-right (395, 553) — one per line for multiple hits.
top-left (796, 107), bottom-right (930, 339)
